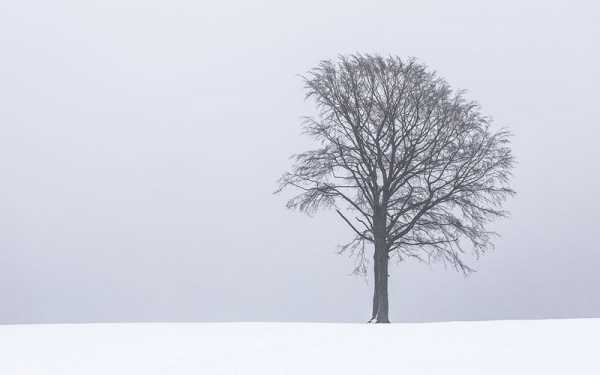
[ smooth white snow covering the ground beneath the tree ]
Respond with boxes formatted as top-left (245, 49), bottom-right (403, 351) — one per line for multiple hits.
top-left (0, 319), bottom-right (600, 375)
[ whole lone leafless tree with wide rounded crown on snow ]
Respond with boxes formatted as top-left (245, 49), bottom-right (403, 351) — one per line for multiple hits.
top-left (277, 55), bottom-right (514, 323)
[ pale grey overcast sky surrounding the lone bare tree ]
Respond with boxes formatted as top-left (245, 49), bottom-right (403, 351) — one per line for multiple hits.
top-left (0, 0), bottom-right (600, 323)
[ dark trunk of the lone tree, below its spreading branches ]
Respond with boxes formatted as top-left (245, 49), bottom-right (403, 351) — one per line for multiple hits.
top-left (371, 212), bottom-right (390, 323)
